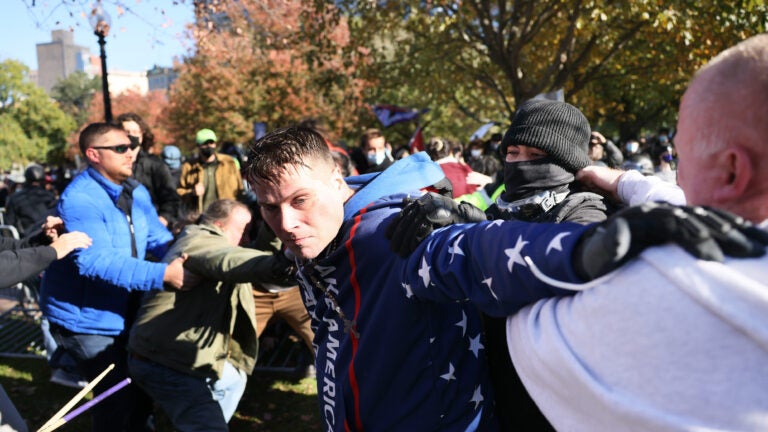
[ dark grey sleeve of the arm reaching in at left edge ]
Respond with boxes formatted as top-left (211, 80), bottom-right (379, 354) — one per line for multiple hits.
top-left (0, 234), bottom-right (56, 288)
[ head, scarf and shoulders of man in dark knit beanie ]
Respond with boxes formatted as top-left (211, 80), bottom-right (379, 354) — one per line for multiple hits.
top-left (488, 100), bottom-right (606, 224)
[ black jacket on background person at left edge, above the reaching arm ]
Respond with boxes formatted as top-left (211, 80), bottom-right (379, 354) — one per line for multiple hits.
top-left (5, 185), bottom-right (56, 237)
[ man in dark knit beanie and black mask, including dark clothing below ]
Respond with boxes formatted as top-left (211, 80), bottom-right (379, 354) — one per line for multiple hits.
top-left (483, 100), bottom-right (606, 430)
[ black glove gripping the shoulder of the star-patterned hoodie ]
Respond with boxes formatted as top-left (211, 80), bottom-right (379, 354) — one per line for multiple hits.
top-left (386, 192), bottom-right (486, 257)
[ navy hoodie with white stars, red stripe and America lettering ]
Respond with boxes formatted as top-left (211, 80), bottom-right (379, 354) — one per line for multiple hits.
top-left (299, 153), bottom-right (584, 431)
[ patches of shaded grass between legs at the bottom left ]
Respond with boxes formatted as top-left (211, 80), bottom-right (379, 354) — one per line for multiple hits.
top-left (0, 358), bottom-right (320, 432)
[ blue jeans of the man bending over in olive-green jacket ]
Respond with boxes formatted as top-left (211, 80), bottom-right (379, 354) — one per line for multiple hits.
top-left (128, 356), bottom-right (247, 432)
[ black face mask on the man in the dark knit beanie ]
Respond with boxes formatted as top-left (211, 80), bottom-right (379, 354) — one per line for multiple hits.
top-left (503, 157), bottom-right (575, 202)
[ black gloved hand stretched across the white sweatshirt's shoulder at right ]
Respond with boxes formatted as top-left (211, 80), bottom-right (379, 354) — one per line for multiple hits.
top-left (573, 203), bottom-right (768, 280)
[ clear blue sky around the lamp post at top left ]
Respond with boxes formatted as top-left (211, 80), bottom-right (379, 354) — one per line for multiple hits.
top-left (0, 0), bottom-right (194, 72)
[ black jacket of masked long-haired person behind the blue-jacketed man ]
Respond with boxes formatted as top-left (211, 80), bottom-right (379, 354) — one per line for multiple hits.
top-left (133, 150), bottom-right (181, 223)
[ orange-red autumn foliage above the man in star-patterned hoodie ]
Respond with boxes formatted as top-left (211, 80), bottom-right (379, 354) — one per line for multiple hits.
top-left (169, 0), bottom-right (368, 147)
